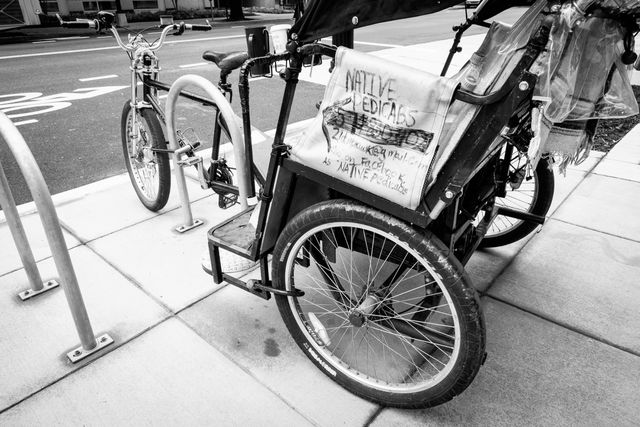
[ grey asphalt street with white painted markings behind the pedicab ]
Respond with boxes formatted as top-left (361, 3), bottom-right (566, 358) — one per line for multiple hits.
top-left (0, 8), bottom-right (521, 204)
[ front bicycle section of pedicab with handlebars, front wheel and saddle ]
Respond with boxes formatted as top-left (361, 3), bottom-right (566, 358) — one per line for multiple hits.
top-left (58, 12), bottom-right (264, 212)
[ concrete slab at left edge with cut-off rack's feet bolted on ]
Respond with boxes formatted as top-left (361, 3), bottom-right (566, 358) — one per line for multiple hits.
top-left (0, 246), bottom-right (169, 412)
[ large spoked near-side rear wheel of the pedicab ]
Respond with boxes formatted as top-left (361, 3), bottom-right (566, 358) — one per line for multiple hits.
top-left (272, 200), bottom-right (485, 408)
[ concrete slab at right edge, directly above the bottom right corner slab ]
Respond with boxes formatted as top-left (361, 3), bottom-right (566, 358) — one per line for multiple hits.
top-left (489, 220), bottom-right (640, 354)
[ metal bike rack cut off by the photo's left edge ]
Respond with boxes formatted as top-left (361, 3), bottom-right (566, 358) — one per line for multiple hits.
top-left (0, 112), bottom-right (113, 363)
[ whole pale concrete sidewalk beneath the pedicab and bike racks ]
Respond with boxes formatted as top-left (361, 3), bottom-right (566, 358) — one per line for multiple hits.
top-left (0, 32), bottom-right (640, 427)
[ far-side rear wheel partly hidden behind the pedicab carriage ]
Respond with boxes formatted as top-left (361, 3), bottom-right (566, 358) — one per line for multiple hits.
top-left (479, 154), bottom-right (555, 248)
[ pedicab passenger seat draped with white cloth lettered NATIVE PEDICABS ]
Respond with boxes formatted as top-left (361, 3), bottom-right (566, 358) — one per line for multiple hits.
top-left (287, 0), bottom-right (546, 222)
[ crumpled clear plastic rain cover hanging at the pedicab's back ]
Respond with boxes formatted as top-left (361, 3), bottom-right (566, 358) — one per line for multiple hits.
top-left (529, 0), bottom-right (640, 170)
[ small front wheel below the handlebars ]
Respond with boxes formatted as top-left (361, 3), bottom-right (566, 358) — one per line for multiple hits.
top-left (120, 101), bottom-right (171, 212)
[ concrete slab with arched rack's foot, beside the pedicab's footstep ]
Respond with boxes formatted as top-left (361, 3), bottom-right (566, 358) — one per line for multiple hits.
top-left (89, 197), bottom-right (239, 312)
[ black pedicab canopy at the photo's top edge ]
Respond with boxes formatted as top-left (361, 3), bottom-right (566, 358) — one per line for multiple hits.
top-left (291, 0), bottom-right (534, 42)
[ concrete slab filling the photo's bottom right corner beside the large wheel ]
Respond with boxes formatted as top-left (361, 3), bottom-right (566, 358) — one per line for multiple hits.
top-left (371, 298), bottom-right (640, 427)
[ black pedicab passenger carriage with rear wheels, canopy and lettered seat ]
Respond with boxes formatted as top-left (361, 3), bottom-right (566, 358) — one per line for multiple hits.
top-left (165, 0), bottom-right (640, 408)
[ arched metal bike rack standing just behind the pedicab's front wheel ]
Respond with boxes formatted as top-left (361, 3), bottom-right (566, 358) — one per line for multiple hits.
top-left (165, 74), bottom-right (251, 232)
